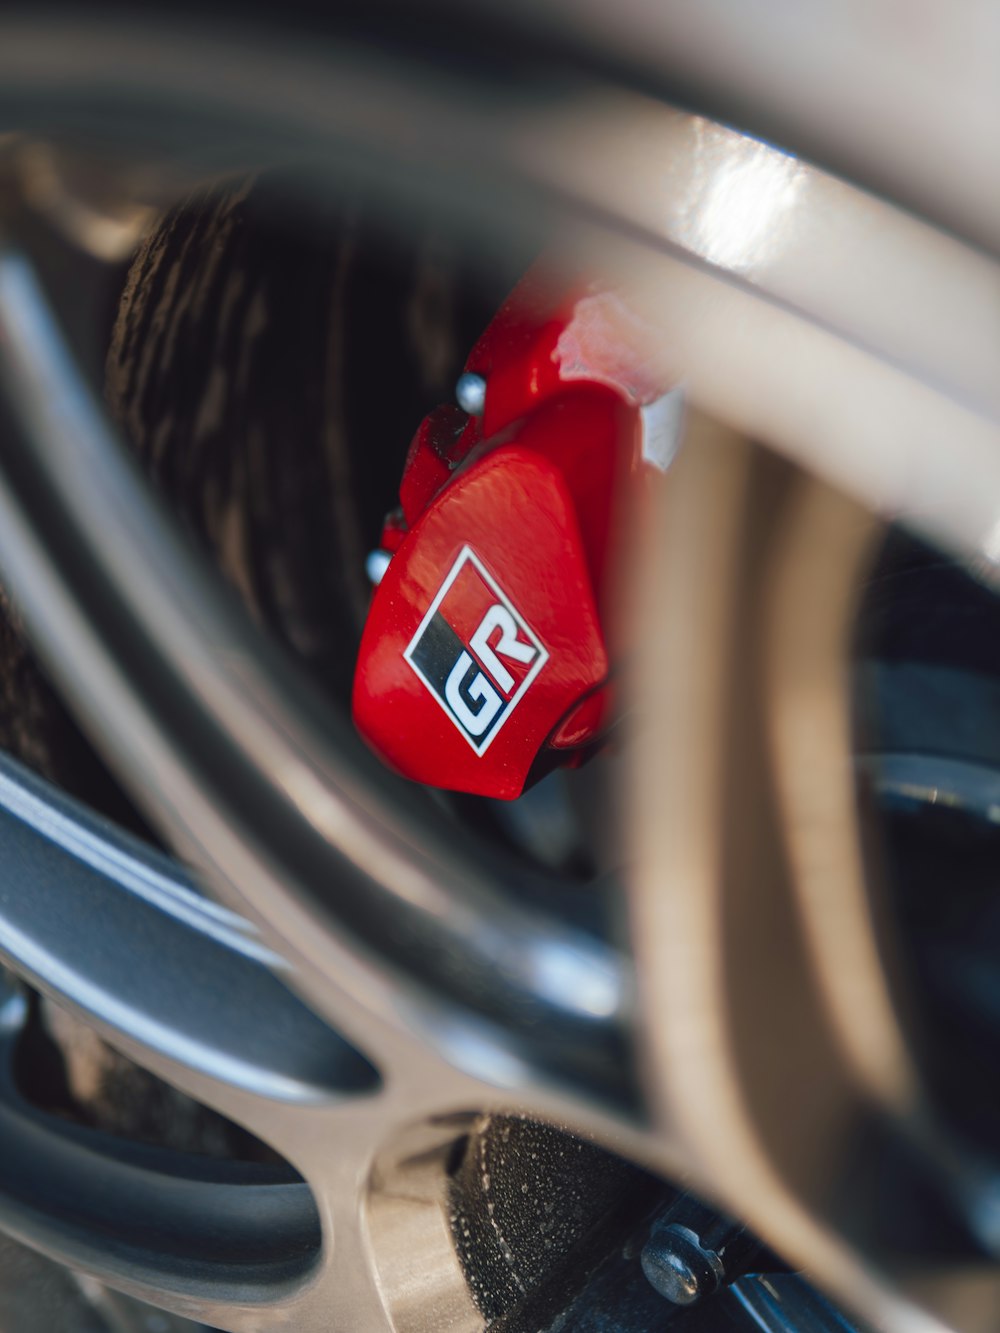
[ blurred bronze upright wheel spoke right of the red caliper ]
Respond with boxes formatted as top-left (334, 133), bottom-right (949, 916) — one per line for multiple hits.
top-left (633, 415), bottom-right (996, 1328)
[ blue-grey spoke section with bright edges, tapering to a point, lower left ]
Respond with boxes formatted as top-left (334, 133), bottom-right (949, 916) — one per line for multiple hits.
top-left (0, 758), bottom-right (377, 1128)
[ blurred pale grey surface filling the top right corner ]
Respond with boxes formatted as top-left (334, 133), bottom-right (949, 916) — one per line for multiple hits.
top-left (493, 0), bottom-right (1000, 253)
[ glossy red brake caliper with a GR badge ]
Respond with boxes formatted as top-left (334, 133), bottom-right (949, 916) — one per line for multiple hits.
top-left (353, 269), bottom-right (676, 798)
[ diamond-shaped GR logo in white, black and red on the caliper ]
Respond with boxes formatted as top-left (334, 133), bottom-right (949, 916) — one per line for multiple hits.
top-left (403, 547), bottom-right (548, 754)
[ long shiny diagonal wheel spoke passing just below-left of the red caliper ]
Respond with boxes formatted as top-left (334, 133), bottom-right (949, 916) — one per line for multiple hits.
top-left (0, 255), bottom-right (635, 1110)
